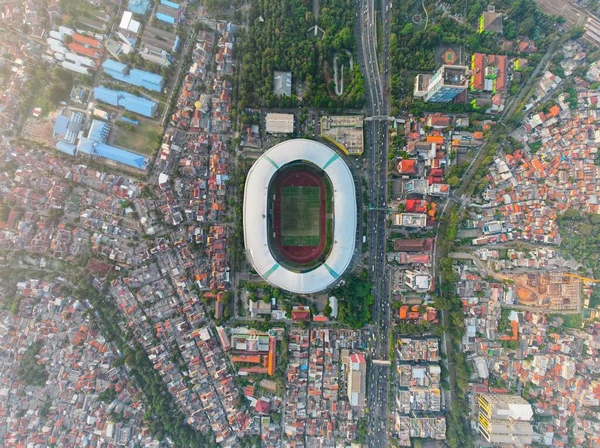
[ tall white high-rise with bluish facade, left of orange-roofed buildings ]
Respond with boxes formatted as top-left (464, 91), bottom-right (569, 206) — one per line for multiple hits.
top-left (414, 65), bottom-right (469, 103)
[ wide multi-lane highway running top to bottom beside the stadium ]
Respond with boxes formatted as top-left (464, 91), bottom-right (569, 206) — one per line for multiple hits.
top-left (356, 0), bottom-right (391, 447)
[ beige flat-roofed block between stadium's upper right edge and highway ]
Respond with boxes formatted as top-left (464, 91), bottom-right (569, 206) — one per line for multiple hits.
top-left (321, 115), bottom-right (364, 156)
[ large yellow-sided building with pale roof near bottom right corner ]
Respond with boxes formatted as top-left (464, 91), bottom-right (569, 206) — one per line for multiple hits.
top-left (478, 394), bottom-right (533, 446)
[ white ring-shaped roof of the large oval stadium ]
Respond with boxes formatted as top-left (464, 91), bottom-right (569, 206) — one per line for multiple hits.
top-left (244, 139), bottom-right (356, 294)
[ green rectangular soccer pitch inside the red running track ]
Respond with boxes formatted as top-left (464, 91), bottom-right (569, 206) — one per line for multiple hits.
top-left (281, 187), bottom-right (321, 246)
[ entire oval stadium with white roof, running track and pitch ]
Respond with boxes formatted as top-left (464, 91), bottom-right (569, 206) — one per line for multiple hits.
top-left (244, 139), bottom-right (356, 294)
